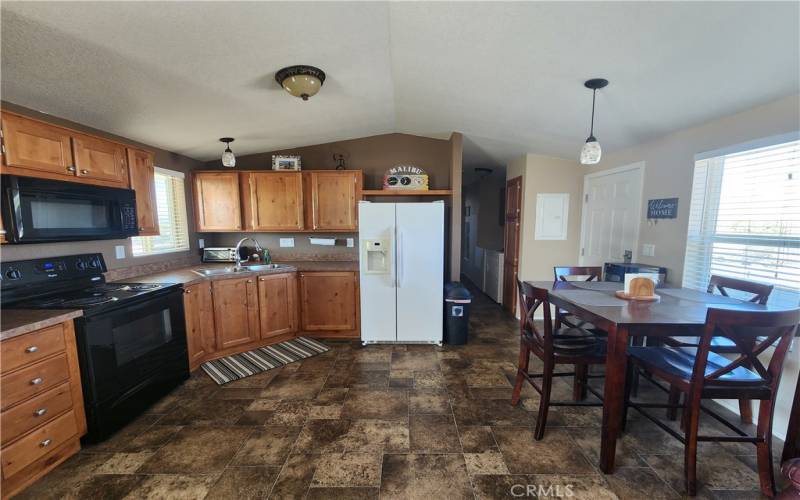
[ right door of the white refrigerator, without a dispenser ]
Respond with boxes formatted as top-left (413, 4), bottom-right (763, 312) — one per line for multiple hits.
top-left (395, 202), bottom-right (444, 342)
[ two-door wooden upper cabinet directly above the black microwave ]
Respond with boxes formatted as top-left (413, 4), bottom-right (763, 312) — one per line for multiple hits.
top-left (1, 112), bottom-right (128, 187)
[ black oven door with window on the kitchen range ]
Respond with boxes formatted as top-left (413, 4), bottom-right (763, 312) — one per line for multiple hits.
top-left (78, 288), bottom-right (189, 408)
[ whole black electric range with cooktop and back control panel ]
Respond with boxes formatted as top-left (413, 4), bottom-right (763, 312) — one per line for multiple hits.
top-left (0, 254), bottom-right (189, 441)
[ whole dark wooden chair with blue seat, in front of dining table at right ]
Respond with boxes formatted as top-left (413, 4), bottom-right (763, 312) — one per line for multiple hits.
top-left (625, 309), bottom-right (800, 496)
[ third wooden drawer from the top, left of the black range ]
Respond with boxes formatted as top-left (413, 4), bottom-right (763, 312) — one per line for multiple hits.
top-left (0, 382), bottom-right (72, 444)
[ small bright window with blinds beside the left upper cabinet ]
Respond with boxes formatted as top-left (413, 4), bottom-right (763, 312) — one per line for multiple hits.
top-left (131, 167), bottom-right (189, 257)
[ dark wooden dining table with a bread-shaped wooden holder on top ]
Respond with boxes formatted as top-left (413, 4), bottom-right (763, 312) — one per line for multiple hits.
top-left (527, 281), bottom-right (800, 474)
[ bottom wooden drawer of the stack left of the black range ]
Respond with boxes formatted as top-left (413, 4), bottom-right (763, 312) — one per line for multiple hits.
top-left (2, 410), bottom-right (78, 478)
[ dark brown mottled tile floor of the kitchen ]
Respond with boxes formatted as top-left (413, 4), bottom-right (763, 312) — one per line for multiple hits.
top-left (19, 288), bottom-right (779, 500)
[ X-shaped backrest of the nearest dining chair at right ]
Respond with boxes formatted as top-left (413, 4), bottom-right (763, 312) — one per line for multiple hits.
top-left (693, 309), bottom-right (800, 390)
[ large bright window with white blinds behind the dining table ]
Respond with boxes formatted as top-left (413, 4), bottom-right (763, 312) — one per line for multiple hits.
top-left (683, 134), bottom-right (800, 307)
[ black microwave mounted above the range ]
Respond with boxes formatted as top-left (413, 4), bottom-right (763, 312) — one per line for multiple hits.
top-left (0, 175), bottom-right (139, 243)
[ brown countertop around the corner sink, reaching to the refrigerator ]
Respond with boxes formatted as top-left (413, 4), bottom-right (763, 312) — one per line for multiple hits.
top-left (122, 261), bottom-right (358, 286)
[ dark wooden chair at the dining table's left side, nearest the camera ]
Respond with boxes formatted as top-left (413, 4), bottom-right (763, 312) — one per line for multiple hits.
top-left (511, 280), bottom-right (606, 441)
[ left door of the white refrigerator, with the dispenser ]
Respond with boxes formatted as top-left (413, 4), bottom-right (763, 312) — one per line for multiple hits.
top-left (358, 202), bottom-right (397, 342)
